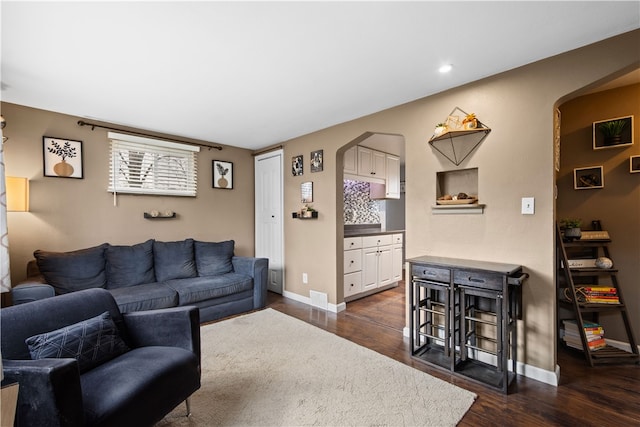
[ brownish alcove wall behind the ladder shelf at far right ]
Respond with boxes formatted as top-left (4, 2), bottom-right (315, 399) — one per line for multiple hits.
top-left (557, 84), bottom-right (640, 342)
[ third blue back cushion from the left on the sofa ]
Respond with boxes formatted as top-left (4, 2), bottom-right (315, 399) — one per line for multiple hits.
top-left (153, 239), bottom-right (197, 282)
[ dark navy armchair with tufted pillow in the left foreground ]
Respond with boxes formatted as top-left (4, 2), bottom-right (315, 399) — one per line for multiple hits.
top-left (0, 289), bottom-right (200, 426)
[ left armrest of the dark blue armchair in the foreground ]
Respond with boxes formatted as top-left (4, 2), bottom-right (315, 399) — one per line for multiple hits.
top-left (2, 359), bottom-right (84, 427)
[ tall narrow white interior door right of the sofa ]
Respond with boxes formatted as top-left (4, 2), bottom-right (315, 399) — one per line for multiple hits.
top-left (255, 150), bottom-right (284, 294)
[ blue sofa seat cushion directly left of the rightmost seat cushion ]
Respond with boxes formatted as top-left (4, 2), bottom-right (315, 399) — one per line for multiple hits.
top-left (109, 283), bottom-right (178, 313)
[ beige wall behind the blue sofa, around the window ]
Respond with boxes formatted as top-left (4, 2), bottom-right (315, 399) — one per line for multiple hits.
top-left (2, 103), bottom-right (254, 283)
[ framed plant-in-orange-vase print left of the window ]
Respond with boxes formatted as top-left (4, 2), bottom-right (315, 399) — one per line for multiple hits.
top-left (42, 136), bottom-right (84, 179)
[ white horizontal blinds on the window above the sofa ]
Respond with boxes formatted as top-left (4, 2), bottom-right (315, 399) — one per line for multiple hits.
top-left (107, 132), bottom-right (200, 197)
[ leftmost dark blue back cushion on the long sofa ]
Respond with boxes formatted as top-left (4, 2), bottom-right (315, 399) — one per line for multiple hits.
top-left (33, 243), bottom-right (108, 294)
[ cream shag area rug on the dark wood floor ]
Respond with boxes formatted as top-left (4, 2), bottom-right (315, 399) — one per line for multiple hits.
top-left (157, 309), bottom-right (476, 427)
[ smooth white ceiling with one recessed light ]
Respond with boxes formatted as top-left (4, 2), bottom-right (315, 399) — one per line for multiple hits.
top-left (1, 0), bottom-right (640, 149)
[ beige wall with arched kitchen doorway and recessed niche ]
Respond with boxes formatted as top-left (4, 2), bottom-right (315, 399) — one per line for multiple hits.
top-left (284, 31), bottom-right (640, 371)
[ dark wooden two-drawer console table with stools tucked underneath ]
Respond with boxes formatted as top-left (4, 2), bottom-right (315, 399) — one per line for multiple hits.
top-left (408, 256), bottom-right (529, 393)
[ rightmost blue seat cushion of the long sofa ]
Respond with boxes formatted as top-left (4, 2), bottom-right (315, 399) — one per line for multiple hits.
top-left (164, 273), bottom-right (253, 305)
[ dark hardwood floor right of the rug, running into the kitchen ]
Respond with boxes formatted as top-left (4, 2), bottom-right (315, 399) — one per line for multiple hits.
top-left (268, 284), bottom-right (640, 426)
